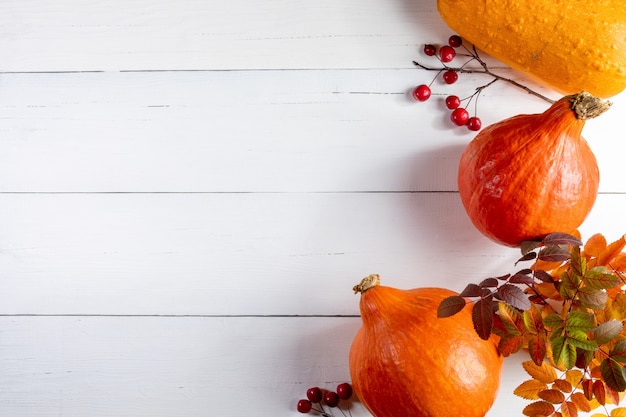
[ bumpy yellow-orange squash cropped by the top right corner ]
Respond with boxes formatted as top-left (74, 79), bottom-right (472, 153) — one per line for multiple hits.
top-left (437, 0), bottom-right (626, 97)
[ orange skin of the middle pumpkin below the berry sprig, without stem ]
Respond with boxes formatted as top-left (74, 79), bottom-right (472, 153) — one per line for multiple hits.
top-left (458, 96), bottom-right (600, 247)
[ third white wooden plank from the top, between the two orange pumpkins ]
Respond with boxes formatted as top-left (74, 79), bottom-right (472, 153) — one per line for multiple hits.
top-left (0, 193), bottom-right (626, 315)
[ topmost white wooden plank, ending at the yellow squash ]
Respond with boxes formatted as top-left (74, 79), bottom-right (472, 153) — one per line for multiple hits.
top-left (0, 0), bottom-right (450, 72)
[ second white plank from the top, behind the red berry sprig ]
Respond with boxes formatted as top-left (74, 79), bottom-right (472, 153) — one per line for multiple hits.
top-left (0, 70), bottom-right (626, 192)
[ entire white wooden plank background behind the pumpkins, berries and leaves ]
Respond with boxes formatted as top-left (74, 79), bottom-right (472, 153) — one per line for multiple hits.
top-left (0, 0), bottom-right (626, 417)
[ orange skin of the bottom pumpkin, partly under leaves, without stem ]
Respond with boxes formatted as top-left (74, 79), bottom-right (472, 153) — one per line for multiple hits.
top-left (350, 286), bottom-right (502, 417)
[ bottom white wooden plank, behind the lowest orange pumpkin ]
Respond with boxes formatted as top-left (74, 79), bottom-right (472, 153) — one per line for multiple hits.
top-left (0, 317), bottom-right (527, 417)
